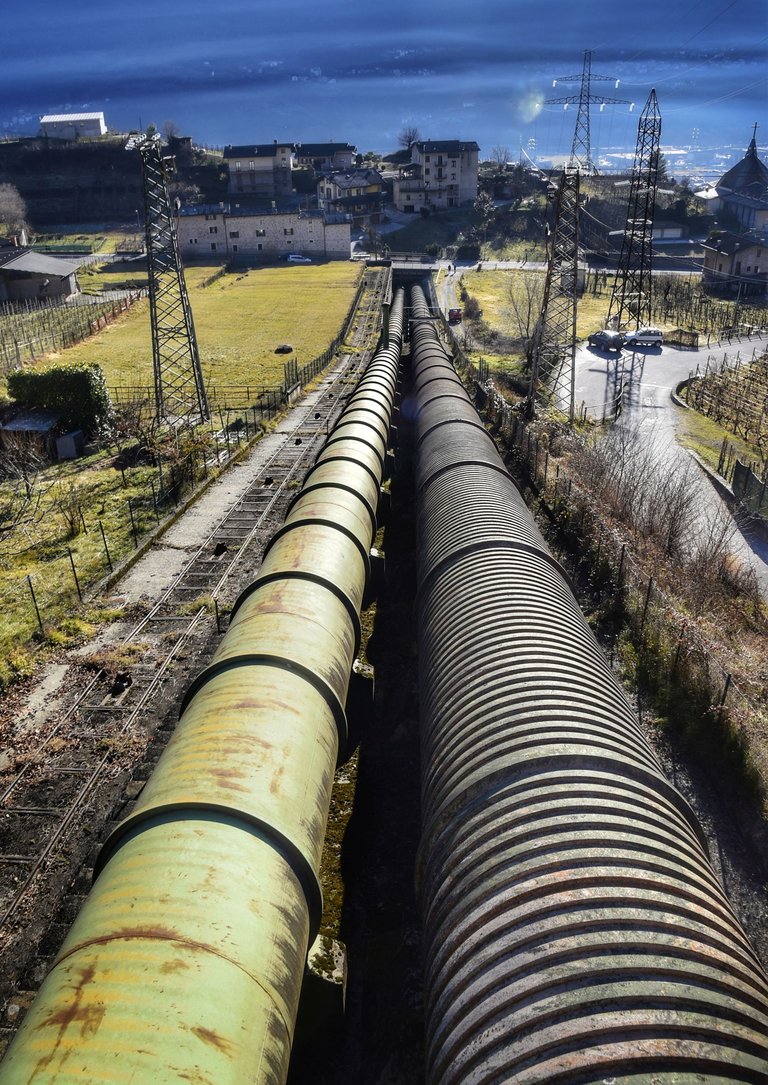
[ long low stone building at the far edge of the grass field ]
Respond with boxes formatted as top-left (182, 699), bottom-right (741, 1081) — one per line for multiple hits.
top-left (178, 205), bottom-right (351, 261)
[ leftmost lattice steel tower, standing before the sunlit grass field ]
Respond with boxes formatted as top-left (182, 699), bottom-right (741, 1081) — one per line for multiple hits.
top-left (126, 133), bottom-right (209, 425)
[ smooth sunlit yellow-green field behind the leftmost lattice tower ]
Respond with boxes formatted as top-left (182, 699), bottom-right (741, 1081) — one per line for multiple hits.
top-left (32, 260), bottom-right (362, 386)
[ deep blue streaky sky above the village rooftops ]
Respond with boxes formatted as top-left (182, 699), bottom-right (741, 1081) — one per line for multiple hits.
top-left (0, 0), bottom-right (768, 153)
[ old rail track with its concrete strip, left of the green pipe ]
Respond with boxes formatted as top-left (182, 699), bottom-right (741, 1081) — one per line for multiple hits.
top-left (0, 264), bottom-right (391, 1050)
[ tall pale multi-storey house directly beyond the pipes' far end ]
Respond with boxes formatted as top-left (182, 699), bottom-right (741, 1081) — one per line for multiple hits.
top-left (393, 140), bottom-right (479, 213)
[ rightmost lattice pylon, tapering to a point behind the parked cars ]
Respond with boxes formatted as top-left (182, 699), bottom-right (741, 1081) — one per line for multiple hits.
top-left (607, 90), bottom-right (662, 330)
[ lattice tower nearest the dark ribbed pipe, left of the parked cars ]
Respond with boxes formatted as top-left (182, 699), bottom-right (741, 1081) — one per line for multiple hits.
top-left (527, 166), bottom-right (579, 424)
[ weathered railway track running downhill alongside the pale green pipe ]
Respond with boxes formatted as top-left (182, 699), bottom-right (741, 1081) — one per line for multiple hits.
top-left (0, 264), bottom-right (388, 1054)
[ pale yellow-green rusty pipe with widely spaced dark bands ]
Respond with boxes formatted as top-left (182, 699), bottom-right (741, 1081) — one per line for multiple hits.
top-left (0, 293), bottom-right (404, 1085)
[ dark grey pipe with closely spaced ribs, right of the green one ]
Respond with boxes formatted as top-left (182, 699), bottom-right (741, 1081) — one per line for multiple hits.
top-left (408, 290), bottom-right (768, 1085)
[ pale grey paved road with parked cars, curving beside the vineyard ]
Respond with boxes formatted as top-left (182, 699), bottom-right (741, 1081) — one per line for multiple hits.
top-left (576, 336), bottom-right (768, 597)
